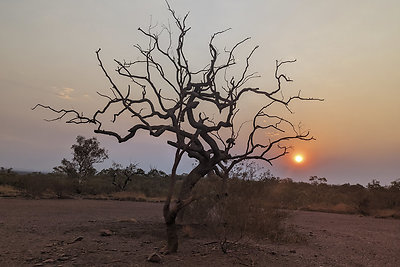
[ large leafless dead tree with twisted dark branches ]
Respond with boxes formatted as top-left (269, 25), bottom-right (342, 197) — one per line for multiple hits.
top-left (35, 3), bottom-right (322, 252)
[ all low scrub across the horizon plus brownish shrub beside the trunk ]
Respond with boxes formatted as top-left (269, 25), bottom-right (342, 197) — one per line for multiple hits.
top-left (0, 164), bottom-right (400, 258)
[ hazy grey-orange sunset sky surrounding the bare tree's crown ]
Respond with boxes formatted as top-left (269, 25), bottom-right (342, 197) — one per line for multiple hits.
top-left (0, 0), bottom-right (400, 184)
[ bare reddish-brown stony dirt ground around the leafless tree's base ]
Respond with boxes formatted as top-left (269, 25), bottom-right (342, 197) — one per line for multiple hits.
top-left (0, 199), bottom-right (400, 266)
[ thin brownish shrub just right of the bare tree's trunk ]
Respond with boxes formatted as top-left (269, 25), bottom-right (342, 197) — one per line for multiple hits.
top-left (183, 177), bottom-right (300, 252)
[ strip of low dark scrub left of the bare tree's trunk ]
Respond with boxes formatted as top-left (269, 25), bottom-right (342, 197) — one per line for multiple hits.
top-left (0, 165), bottom-right (172, 201)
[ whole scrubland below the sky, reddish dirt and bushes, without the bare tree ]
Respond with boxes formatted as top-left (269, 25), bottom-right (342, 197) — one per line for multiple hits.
top-left (0, 171), bottom-right (400, 266)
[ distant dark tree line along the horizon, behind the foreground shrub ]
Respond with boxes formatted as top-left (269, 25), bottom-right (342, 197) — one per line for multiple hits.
top-left (0, 159), bottom-right (400, 218)
